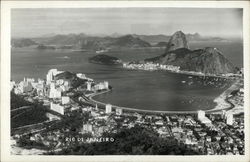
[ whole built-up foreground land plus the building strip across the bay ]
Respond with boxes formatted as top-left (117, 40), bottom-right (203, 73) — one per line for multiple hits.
top-left (11, 67), bottom-right (245, 155)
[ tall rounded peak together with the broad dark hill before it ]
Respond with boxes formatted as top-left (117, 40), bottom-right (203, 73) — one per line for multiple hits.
top-left (144, 31), bottom-right (237, 75)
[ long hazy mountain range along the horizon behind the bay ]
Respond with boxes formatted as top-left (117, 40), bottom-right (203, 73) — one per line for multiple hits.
top-left (11, 33), bottom-right (225, 50)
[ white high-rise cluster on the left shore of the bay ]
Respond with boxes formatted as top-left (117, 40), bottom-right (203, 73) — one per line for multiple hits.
top-left (11, 69), bottom-right (109, 116)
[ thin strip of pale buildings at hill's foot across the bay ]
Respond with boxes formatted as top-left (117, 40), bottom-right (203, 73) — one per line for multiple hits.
top-left (123, 62), bottom-right (180, 72)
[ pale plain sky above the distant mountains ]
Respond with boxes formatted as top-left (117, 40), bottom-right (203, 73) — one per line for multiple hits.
top-left (11, 8), bottom-right (243, 37)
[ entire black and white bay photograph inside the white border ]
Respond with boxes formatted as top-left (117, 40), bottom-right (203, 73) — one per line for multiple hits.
top-left (2, 0), bottom-right (249, 161)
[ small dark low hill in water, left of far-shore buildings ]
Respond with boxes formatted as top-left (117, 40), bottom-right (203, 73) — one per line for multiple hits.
top-left (89, 54), bottom-right (122, 65)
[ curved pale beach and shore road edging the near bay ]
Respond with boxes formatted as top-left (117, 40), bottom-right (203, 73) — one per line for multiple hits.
top-left (86, 81), bottom-right (239, 114)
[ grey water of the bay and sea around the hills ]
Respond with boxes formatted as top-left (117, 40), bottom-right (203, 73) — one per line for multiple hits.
top-left (11, 42), bottom-right (243, 111)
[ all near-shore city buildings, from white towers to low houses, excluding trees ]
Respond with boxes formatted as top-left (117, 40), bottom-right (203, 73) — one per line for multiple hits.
top-left (11, 68), bottom-right (245, 155)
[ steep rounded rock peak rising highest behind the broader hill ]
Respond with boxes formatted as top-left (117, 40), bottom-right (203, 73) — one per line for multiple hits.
top-left (166, 31), bottom-right (189, 52)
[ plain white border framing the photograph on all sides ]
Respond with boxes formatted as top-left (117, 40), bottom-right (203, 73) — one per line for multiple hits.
top-left (0, 1), bottom-right (250, 162)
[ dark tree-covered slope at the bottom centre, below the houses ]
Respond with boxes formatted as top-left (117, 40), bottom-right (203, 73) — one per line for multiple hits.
top-left (50, 126), bottom-right (199, 155)
